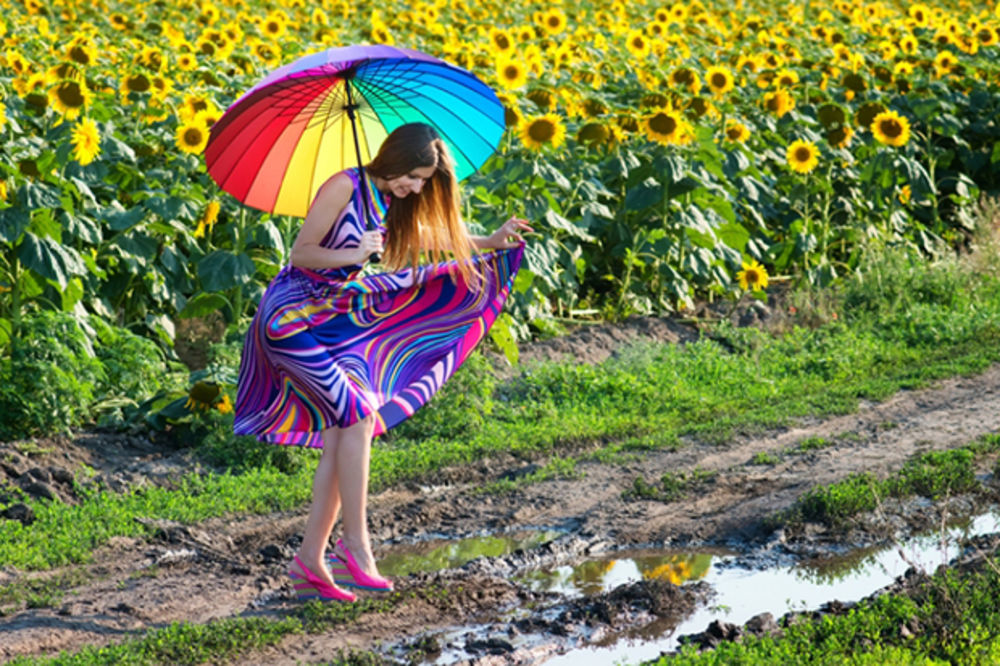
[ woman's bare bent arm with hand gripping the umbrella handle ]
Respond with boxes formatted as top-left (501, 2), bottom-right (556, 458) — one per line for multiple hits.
top-left (291, 174), bottom-right (382, 268)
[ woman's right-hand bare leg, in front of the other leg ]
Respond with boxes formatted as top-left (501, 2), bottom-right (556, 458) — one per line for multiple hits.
top-left (337, 416), bottom-right (378, 576)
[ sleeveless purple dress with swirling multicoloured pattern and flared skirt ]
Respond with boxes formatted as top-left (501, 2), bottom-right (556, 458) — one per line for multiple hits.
top-left (234, 169), bottom-right (524, 448)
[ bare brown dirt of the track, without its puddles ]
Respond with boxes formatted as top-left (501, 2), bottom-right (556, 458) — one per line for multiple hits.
top-left (0, 358), bottom-right (1000, 664)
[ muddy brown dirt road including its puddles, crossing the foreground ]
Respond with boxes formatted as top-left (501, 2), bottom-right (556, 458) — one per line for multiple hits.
top-left (0, 320), bottom-right (1000, 664)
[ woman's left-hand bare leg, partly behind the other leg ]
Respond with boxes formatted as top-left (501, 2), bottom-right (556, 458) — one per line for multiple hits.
top-left (292, 428), bottom-right (342, 583)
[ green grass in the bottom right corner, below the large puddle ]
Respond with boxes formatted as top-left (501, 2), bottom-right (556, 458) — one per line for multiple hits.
top-left (647, 554), bottom-right (1000, 666)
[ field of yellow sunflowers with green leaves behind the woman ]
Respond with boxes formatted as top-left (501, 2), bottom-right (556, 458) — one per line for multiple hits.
top-left (0, 0), bottom-right (1000, 357)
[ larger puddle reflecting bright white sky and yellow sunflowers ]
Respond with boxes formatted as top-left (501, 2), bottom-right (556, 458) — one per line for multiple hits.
top-left (522, 513), bottom-right (1000, 666)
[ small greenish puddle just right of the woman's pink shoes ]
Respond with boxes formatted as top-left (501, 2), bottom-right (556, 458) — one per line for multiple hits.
top-left (378, 531), bottom-right (562, 577)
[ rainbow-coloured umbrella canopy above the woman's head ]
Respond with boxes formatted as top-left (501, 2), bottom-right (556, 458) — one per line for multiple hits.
top-left (205, 45), bottom-right (504, 217)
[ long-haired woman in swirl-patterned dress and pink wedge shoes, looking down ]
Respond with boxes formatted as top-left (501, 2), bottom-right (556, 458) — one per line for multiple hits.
top-left (234, 123), bottom-right (532, 601)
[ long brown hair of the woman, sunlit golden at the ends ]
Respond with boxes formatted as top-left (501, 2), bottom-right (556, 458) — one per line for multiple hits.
top-left (365, 123), bottom-right (478, 283)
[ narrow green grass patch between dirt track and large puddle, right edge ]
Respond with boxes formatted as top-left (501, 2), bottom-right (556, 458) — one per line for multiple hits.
top-left (768, 434), bottom-right (1000, 526)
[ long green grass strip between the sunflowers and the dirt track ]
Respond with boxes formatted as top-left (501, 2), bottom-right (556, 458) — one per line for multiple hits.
top-left (0, 244), bottom-right (1000, 569)
